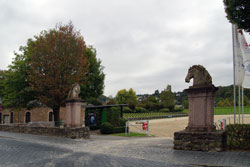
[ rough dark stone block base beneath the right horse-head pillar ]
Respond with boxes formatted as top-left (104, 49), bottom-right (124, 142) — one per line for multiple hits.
top-left (174, 131), bottom-right (226, 151)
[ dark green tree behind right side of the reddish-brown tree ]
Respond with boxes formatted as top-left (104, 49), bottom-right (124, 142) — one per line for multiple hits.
top-left (80, 46), bottom-right (105, 103)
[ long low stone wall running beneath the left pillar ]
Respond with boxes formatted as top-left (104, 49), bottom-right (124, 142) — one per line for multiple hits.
top-left (0, 125), bottom-right (90, 139)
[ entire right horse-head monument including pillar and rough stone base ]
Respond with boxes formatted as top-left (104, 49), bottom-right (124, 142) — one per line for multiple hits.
top-left (174, 65), bottom-right (226, 151)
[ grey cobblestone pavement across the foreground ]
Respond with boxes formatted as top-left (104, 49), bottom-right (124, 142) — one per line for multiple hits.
top-left (0, 132), bottom-right (250, 167)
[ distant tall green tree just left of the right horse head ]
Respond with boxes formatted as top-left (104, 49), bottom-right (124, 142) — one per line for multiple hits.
top-left (160, 85), bottom-right (175, 111)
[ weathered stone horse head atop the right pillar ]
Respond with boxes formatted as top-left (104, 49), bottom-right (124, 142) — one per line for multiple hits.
top-left (185, 65), bottom-right (213, 87)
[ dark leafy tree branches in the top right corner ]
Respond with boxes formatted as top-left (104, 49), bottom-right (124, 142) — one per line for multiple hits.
top-left (223, 0), bottom-right (250, 32)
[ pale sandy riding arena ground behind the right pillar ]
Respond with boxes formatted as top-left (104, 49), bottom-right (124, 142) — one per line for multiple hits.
top-left (130, 115), bottom-right (250, 138)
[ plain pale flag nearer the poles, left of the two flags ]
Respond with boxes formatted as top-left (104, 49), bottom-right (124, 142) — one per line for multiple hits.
top-left (233, 25), bottom-right (245, 86)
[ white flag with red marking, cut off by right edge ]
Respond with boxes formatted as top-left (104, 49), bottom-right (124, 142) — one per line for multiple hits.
top-left (238, 30), bottom-right (250, 88)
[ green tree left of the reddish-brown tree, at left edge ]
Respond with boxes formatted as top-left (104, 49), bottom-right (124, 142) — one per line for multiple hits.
top-left (0, 47), bottom-right (36, 108)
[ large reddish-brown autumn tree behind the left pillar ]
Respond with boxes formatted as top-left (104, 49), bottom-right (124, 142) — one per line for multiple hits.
top-left (27, 22), bottom-right (88, 122)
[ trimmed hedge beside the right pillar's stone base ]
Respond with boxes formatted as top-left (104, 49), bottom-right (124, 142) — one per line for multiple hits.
top-left (226, 124), bottom-right (250, 150)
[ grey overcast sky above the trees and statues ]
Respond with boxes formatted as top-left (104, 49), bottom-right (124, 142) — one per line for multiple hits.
top-left (0, 0), bottom-right (243, 96)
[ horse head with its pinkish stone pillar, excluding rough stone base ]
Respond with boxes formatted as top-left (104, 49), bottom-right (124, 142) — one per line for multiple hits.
top-left (185, 65), bottom-right (218, 132)
